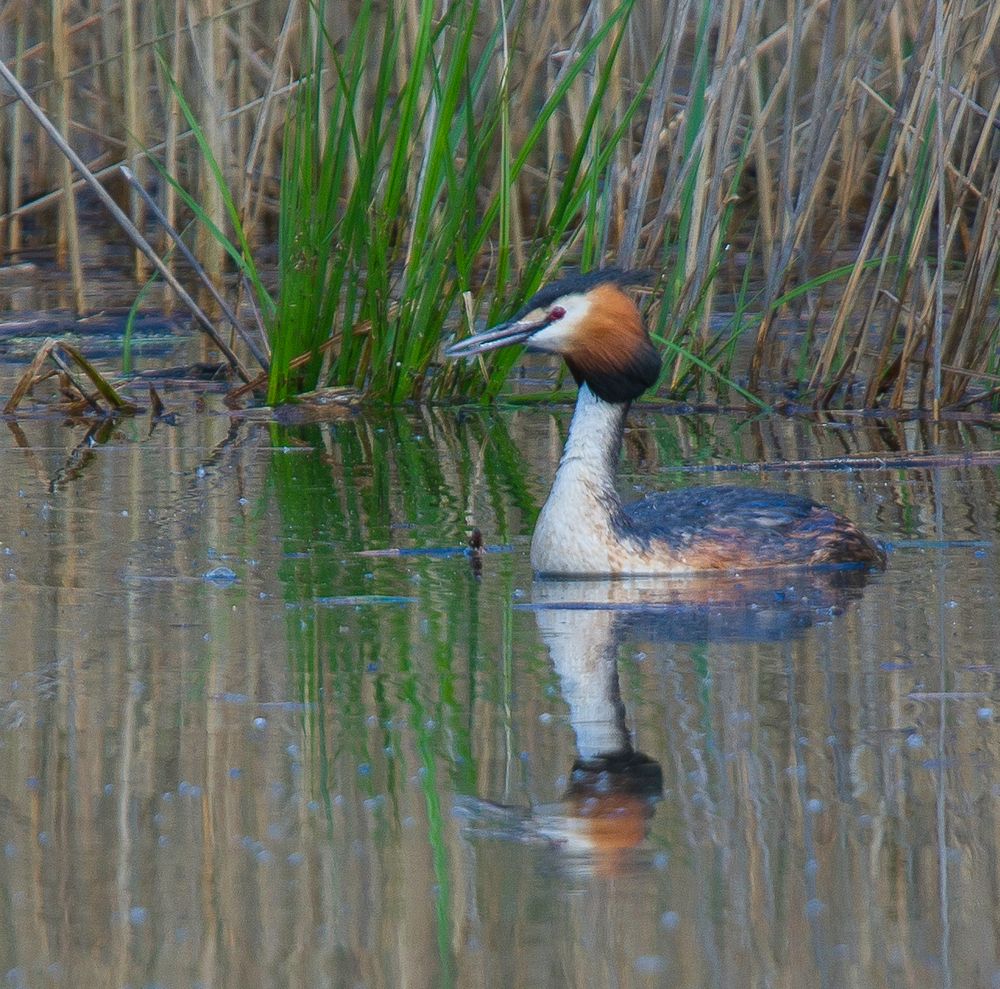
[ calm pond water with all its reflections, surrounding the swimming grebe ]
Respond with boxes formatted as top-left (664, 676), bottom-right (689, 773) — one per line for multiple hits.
top-left (0, 374), bottom-right (1000, 987)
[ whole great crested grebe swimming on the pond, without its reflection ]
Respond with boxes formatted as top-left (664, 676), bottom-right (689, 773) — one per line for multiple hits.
top-left (445, 268), bottom-right (885, 576)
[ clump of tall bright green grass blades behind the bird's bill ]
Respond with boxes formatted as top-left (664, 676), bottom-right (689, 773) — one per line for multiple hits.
top-left (268, 0), bottom-right (645, 403)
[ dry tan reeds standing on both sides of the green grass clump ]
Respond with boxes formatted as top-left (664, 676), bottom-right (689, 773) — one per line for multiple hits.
top-left (0, 0), bottom-right (1000, 410)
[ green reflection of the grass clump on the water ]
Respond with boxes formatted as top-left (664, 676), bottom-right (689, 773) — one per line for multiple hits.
top-left (265, 412), bottom-right (537, 985)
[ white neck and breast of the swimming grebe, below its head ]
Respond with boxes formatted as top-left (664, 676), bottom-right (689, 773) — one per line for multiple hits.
top-left (531, 384), bottom-right (628, 574)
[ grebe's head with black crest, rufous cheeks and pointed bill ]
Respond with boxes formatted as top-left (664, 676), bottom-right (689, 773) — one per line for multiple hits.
top-left (444, 268), bottom-right (660, 402)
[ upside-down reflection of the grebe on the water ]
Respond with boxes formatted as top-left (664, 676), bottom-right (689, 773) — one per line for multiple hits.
top-left (456, 568), bottom-right (869, 874)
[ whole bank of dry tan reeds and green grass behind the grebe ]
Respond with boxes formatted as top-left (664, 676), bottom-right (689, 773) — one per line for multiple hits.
top-left (0, 0), bottom-right (1000, 412)
